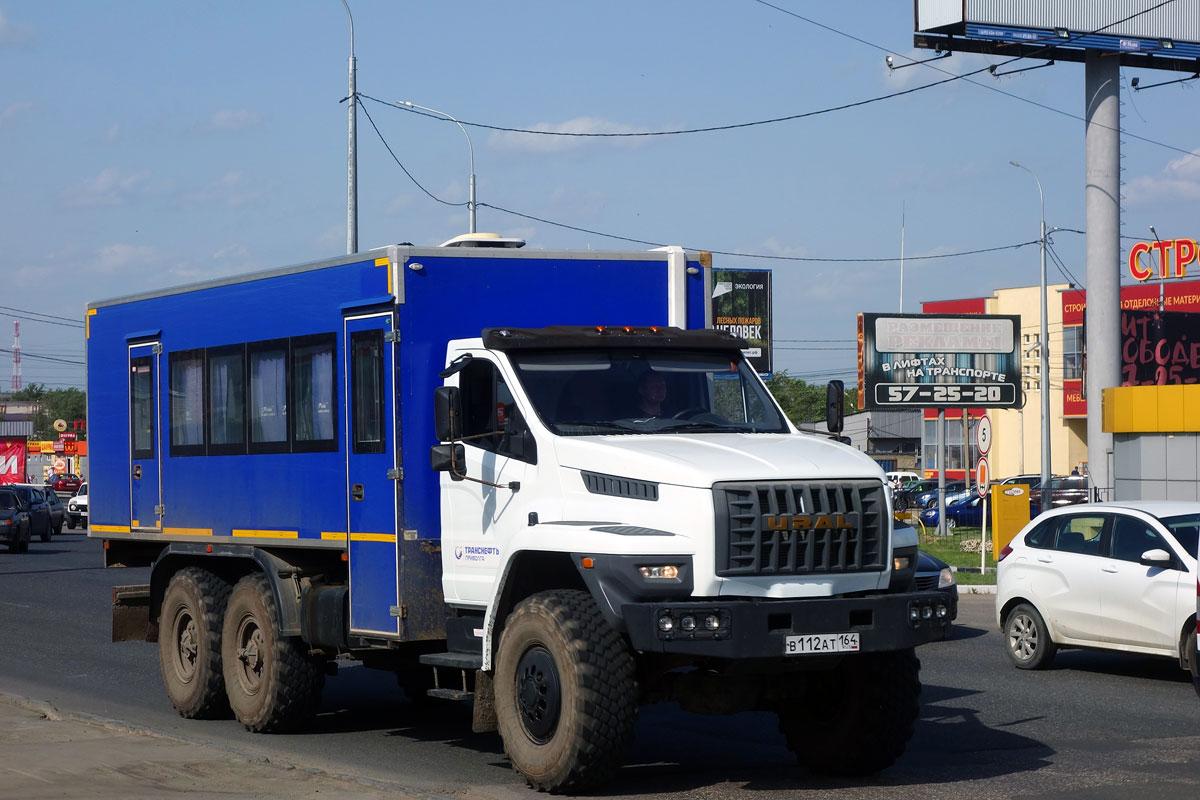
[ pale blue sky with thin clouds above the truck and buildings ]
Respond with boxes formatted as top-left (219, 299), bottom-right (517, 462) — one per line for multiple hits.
top-left (0, 0), bottom-right (1200, 390)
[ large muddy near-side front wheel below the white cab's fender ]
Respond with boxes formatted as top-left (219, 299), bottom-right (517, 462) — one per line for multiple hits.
top-left (496, 590), bottom-right (637, 792)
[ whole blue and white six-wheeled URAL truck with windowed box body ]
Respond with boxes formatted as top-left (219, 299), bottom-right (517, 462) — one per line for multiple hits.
top-left (86, 242), bottom-right (953, 792)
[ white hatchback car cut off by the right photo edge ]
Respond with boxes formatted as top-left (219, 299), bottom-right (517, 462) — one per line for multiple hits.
top-left (996, 500), bottom-right (1200, 692)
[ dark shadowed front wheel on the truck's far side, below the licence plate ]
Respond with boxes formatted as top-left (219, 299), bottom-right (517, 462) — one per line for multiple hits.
top-left (779, 648), bottom-right (920, 776)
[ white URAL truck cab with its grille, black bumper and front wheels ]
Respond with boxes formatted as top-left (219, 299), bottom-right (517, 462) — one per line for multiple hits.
top-left (422, 327), bottom-right (953, 789)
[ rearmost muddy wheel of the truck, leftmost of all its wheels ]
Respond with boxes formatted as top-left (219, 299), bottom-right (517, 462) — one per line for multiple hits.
top-left (158, 567), bottom-right (229, 720)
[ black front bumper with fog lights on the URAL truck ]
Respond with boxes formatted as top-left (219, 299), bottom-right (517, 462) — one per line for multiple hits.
top-left (622, 591), bottom-right (954, 661)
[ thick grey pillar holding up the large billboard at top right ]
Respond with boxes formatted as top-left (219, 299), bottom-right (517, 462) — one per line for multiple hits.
top-left (1084, 50), bottom-right (1121, 499)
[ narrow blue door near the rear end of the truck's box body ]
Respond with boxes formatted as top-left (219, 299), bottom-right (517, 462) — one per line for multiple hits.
top-left (128, 342), bottom-right (162, 531)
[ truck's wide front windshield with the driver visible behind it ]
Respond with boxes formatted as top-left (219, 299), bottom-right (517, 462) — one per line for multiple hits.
top-left (510, 348), bottom-right (788, 437)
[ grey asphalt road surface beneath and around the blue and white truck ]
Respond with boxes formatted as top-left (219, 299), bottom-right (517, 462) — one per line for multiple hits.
top-left (0, 531), bottom-right (1200, 800)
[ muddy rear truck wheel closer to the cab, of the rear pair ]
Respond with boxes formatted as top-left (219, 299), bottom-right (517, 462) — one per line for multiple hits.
top-left (221, 573), bottom-right (325, 733)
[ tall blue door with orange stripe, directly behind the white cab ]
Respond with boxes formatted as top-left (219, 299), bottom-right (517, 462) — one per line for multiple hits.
top-left (342, 313), bottom-right (400, 636)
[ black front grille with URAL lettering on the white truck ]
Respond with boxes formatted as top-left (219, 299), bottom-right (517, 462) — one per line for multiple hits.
top-left (713, 481), bottom-right (888, 577)
